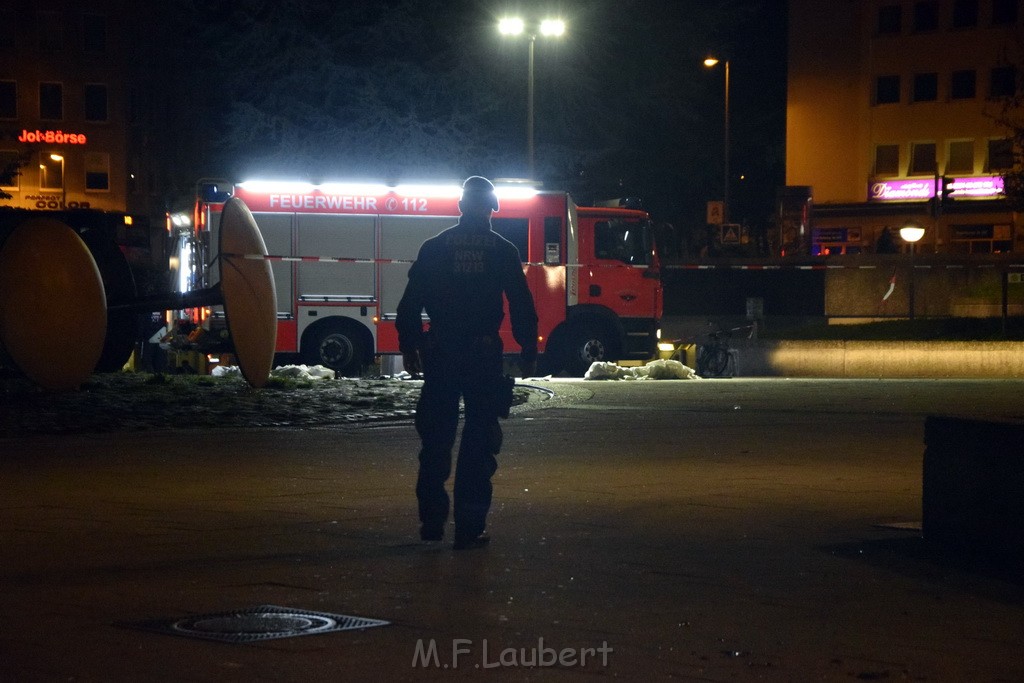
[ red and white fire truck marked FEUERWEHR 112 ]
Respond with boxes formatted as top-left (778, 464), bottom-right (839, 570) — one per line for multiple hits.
top-left (182, 181), bottom-right (663, 375)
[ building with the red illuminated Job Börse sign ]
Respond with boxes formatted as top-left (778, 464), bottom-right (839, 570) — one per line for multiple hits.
top-left (0, 0), bottom-right (141, 211)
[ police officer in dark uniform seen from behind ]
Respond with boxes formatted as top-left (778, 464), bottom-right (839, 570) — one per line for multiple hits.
top-left (395, 175), bottom-right (537, 550)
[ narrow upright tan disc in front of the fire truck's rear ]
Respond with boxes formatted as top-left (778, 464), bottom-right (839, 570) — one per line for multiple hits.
top-left (219, 198), bottom-right (278, 388)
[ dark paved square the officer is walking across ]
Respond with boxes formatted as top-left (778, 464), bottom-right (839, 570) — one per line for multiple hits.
top-left (0, 380), bottom-right (1024, 681)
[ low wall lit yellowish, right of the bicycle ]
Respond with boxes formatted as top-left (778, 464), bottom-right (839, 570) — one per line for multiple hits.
top-left (732, 340), bottom-right (1024, 379)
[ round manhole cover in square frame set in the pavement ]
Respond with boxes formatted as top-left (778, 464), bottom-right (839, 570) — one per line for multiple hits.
top-left (118, 605), bottom-right (388, 643)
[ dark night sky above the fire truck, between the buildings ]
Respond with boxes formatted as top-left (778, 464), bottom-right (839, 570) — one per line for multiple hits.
top-left (144, 0), bottom-right (785, 230)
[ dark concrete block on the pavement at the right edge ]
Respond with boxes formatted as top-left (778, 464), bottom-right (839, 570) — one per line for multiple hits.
top-left (922, 416), bottom-right (1024, 565)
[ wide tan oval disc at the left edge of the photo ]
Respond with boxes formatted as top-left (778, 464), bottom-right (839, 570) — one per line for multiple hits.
top-left (0, 218), bottom-right (106, 391)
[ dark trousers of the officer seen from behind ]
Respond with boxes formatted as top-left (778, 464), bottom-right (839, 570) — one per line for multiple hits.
top-left (416, 339), bottom-right (502, 538)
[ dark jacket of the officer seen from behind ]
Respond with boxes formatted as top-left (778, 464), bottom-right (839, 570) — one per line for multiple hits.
top-left (395, 217), bottom-right (537, 360)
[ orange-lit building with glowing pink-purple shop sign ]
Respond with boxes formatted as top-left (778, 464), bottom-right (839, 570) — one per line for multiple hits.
top-left (786, 0), bottom-right (1024, 254)
